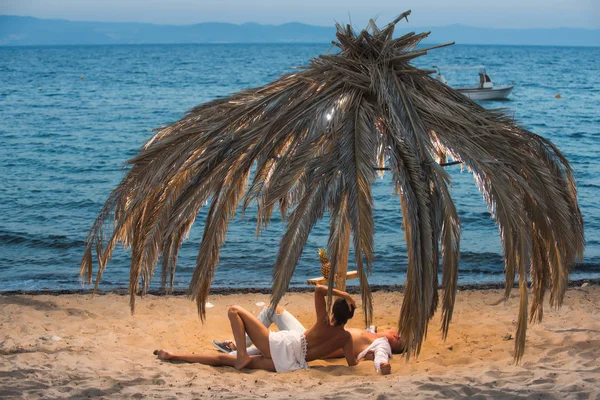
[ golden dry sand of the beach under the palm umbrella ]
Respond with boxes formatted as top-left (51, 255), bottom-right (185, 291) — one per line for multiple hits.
top-left (0, 286), bottom-right (600, 399)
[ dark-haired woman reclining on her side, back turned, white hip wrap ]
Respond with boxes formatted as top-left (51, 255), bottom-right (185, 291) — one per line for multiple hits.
top-left (154, 286), bottom-right (358, 372)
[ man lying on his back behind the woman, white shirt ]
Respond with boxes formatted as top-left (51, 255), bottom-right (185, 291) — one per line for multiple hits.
top-left (213, 286), bottom-right (404, 375)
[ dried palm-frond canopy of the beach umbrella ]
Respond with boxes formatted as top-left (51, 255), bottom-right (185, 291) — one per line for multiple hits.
top-left (81, 12), bottom-right (584, 360)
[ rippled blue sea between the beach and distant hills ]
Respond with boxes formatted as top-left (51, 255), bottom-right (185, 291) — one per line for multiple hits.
top-left (0, 44), bottom-right (600, 291)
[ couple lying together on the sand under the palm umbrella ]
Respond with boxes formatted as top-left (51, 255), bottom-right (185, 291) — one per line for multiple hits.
top-left (155, 285), bottom-right (403, 374)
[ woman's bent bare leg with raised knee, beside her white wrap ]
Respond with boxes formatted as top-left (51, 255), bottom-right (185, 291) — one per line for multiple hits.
top-left (228, 306), bottom-right (271, 369)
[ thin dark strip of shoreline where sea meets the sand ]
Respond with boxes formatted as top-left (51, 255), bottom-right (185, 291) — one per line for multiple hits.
top-left (0, 278), bottom-right (600, 296)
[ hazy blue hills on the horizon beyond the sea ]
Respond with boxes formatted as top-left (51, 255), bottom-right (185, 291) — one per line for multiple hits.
top-left (0, 15), bottom-right (600, 47)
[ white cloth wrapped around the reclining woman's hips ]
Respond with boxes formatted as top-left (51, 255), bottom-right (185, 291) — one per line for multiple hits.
top-left (269, 331), bottom-right (308, 372)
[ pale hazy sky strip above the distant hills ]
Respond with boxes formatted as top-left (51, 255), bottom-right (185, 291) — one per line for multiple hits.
top-left (0, 0), bottom-right (600, 29)
